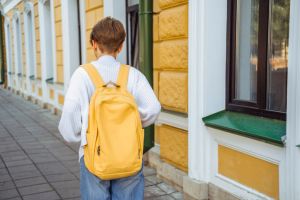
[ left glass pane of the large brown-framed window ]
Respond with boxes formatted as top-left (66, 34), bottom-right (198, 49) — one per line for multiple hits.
top-left (235, 0), bottom-right (259, 102)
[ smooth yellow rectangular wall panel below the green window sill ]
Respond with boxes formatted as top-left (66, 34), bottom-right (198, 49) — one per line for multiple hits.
top-left (218, 145), bottom-right (279, 199)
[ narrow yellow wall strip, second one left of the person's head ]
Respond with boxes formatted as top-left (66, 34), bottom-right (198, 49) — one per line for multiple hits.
top-left (54, 0), bottom-right (64, 83)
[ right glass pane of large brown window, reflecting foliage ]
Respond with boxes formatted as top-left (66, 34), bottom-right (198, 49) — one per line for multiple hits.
top-left (267, 0), bottom-right (290, 112)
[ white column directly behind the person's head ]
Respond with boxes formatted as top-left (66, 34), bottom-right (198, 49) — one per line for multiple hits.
top-left (104, 0), bottom-right (127, 63)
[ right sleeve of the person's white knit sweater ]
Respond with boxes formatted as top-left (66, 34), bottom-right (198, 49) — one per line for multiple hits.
top-left (135, 72), bottom-right (161, 128)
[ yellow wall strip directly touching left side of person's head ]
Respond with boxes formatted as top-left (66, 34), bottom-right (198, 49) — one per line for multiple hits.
top-left (85, 0), bottom-right (103, 62)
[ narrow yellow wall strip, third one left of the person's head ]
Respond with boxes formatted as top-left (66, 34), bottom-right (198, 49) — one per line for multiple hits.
top-left (34, 0), bottom-right (42, 79)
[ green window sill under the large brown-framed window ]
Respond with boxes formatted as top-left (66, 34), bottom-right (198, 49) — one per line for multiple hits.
top-left (202, 111), bottom-right (286, 146)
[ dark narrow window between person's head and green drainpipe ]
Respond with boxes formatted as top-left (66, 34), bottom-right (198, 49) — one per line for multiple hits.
top-left (126, 0), bottom-right (139, 68)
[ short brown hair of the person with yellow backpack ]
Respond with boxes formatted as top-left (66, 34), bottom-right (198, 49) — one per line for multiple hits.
top-left (90, 17), bottom-right (126, 53)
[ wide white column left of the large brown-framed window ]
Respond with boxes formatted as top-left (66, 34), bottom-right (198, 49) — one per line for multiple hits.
top-left (188, 0), bottom-right (227, 181)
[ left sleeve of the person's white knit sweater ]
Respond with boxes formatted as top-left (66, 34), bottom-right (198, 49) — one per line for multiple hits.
top-left (58, 69), bottom-right (86, 142)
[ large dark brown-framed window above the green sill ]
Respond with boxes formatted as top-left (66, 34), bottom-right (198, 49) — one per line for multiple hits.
top-left (226, 0), bottom-right (290, 119)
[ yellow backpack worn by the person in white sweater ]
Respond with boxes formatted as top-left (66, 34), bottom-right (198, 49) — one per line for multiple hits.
top-left (83, 64), bottom-right (144, 180)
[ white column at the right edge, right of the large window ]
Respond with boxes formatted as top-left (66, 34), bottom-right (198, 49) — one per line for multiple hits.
top-left (283, 0), bottom-right (300, 200)
